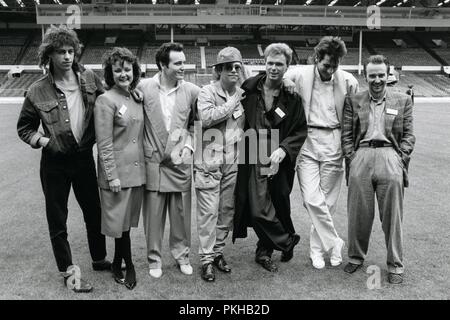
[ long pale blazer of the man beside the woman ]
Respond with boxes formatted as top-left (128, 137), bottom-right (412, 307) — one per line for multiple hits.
top-left (138, 73), bottom-right (200, 192)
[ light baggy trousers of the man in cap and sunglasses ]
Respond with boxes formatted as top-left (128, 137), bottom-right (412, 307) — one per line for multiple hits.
top-left (194, 164), bottom-right (237, 264)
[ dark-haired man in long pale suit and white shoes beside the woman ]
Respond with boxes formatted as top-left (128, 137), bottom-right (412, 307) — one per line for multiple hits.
top-left (138, 43), bottom-right (200, 278)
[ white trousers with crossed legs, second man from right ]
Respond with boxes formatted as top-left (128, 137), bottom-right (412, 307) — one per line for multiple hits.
top-left (297, 128), bottom-right (344, 256)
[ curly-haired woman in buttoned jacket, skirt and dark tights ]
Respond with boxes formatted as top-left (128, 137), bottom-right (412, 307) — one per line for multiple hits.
top-left (94, 48), bottom-right (145, 290)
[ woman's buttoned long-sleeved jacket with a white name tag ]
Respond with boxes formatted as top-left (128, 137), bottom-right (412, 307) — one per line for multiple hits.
top-left (94, 87), bottom-right (145, 189)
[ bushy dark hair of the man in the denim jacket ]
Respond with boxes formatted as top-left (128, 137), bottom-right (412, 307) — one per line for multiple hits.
top-left (38, 24), bottom-right (81, 67)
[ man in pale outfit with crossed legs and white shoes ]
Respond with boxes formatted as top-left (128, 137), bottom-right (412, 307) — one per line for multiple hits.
top-left (285, 36), bottom-right (358, 269)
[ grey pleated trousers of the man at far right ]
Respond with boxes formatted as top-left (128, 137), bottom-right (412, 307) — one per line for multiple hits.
top-left (347, 147), bottom-right (404, 273)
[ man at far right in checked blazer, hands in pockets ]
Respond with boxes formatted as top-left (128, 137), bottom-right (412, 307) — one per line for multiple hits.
top-left (342, 55), bottom-right (416, 284)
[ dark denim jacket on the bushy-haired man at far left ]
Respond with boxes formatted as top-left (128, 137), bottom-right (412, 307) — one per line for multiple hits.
top-left (17, 63), bottom-right (104, 155)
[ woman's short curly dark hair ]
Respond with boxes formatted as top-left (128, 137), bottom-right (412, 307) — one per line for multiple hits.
top-left (103, 47), bottom-right (141, 89)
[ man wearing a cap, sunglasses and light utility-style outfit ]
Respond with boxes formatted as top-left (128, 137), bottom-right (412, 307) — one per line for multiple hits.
top-left (194, 47), bottom-right (244, 282)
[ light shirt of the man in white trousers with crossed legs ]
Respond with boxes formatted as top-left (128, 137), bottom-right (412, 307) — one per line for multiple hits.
top-left (308, 67), bottom-right (340, 128)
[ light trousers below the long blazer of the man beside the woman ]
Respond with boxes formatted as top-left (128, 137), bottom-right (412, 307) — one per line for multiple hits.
top-left (143, 190), bottom-right (191, 269)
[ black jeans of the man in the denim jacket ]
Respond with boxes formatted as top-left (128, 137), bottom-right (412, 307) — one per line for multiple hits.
top-left (40, 150), bottom-right (106, 272)
